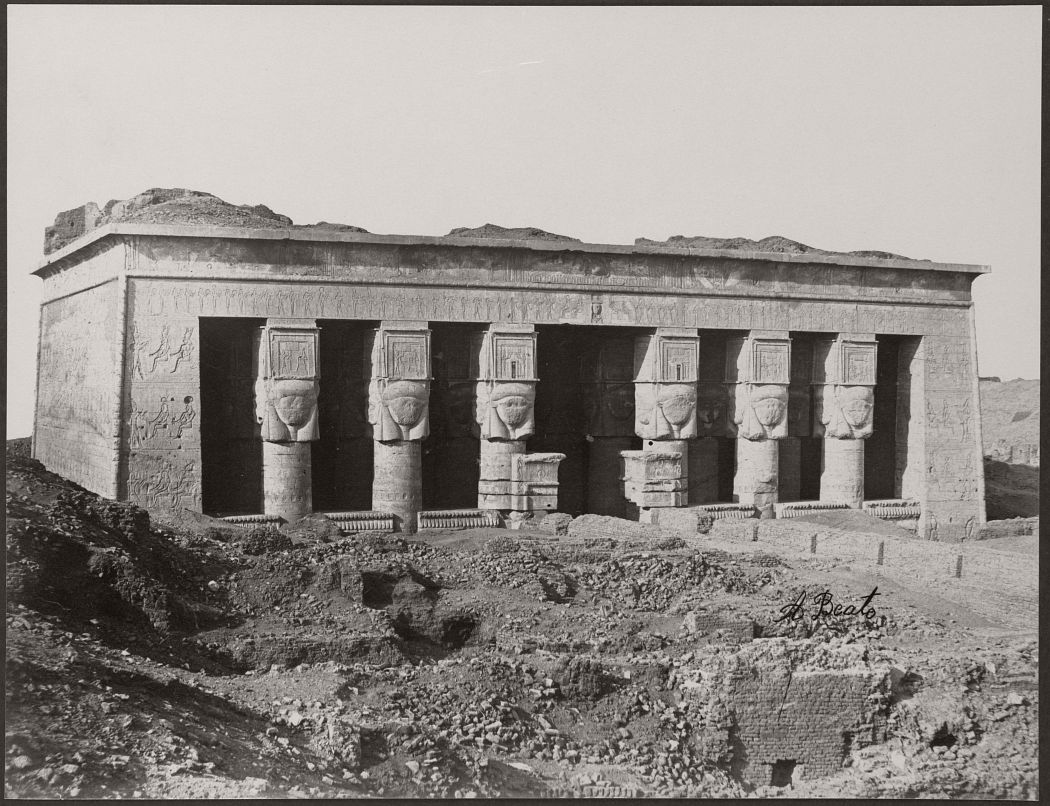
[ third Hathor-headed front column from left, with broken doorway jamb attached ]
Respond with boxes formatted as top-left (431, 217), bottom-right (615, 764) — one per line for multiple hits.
top-left (470, 323), bottom-right (565, 512)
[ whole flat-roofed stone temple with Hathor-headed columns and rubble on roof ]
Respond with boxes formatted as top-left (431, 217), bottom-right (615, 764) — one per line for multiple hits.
top-left (34, 190), bottom-right (988, 539)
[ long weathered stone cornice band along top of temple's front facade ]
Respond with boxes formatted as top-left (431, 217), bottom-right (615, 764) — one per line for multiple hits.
top-left (112, 236), bottom-right (973, 310)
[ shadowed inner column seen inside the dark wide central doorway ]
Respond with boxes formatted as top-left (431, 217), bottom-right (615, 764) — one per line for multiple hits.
top-left (580, 337), bottom-right (636, 517)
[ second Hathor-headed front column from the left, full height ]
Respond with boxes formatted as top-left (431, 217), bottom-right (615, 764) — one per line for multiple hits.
top-left (365, 321), bottom-right (431, 534)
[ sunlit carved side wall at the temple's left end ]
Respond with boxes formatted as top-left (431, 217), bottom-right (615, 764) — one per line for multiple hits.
top-left (33, 245), bottom-right (124, 499)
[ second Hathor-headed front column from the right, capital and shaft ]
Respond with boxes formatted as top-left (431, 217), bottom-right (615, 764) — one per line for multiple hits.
top-left (726, 331), bottom-right (791, 517)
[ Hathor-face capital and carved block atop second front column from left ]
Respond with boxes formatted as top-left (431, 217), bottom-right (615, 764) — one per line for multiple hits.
top-left (365, 321), bottom-right (432, 442)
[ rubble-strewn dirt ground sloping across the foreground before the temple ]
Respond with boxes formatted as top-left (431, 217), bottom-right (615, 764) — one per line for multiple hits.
top-left (5, 447), bottom-right (1037, 799)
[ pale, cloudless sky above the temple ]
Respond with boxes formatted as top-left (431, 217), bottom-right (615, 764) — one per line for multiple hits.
top-left (7, 5), bottom-right (1042, 438)
